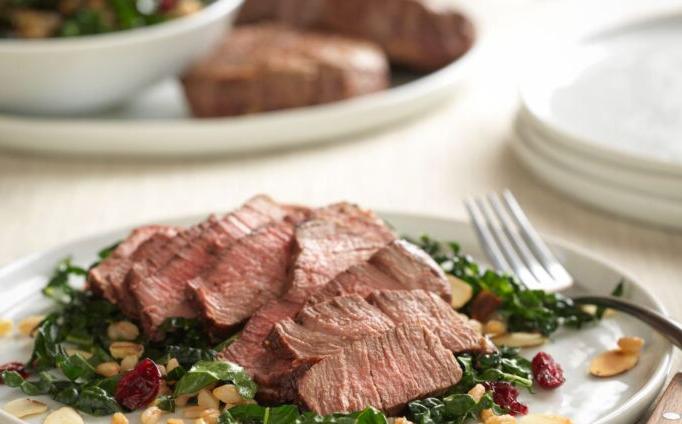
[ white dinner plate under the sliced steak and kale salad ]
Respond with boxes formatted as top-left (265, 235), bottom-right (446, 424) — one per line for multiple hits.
top-left (0, 214), bottom-right (672, 424)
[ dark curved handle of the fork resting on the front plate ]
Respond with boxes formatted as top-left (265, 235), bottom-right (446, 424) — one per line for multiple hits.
top-left (573, 296), bottom-right (682, 349)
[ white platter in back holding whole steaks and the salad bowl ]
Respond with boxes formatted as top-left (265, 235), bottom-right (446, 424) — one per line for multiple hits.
top-left (0, 43), bottom-right (476, 157)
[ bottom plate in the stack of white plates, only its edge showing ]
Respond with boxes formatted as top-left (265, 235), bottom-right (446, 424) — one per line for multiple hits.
top-left (512, 122), bottom-right (682, 229)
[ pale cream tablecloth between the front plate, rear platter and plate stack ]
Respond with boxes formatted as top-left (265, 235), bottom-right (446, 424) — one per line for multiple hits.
top-left (0, 0), bottom-right (682, 420)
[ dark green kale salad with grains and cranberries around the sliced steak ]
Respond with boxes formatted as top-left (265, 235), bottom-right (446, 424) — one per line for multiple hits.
top-left (0, 237), bottom-right (622, 424)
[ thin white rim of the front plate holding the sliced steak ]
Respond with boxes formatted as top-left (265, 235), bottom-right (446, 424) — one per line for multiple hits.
top-left (0, 210), bottom-right (675, 424)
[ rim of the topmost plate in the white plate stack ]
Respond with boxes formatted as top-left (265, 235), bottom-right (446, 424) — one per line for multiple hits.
top-left (517, 9), bottom-right (682, 177)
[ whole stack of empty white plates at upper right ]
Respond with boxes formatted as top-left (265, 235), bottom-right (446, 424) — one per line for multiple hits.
top-left (514, 15), bottom-right (682, 228)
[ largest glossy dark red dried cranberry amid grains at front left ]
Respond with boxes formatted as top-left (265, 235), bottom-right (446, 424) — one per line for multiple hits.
top-left (116, 359), bottom-right (161, 410)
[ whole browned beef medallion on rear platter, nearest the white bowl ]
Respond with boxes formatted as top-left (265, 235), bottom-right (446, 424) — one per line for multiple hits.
top-left (182, 24), bottom-right (389, 117)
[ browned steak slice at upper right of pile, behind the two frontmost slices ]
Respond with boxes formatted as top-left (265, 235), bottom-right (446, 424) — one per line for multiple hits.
top-left (308, 240), bottom-right (451, 303)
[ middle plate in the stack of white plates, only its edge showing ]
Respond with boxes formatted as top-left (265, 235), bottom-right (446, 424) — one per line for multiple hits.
top-left (516, 106), bottom-right (682, 202)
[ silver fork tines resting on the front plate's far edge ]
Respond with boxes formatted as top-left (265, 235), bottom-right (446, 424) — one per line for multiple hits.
top-left (464, 190), bottom-right (573, 291)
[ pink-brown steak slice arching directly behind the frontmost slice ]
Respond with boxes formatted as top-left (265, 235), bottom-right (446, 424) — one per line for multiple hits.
top-left (268, 290), bottom-right (488, 362)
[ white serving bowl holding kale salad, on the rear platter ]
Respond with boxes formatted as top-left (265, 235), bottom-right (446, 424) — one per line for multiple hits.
top-left (0, 0), bottom-right (243, 114)
